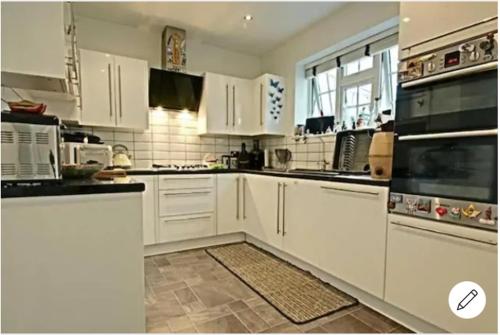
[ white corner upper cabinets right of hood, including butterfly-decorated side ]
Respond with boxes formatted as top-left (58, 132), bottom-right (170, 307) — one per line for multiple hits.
top-left (198, 73), bottom-right (285, 136)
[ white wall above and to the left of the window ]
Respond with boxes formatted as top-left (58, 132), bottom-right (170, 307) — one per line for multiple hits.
top-left (262, 2), bottom-right (399, 132)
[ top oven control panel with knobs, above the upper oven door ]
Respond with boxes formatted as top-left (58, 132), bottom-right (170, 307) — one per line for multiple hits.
top-left (399, 32), bottom-right (498, 82)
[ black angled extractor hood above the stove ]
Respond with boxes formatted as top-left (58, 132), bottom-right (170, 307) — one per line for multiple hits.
top-left (149, 69), bottom-right (203, 112)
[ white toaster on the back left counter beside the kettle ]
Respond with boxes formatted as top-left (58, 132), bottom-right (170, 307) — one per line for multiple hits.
top-left (61, 142), bottom-right (113, 168)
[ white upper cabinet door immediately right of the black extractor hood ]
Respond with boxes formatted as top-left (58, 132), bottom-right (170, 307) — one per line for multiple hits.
top-left (198, 73), bottom-right (232, 135)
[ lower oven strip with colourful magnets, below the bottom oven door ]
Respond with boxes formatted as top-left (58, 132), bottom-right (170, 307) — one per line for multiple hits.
top-left (388, 192), bottom-right (498, 231)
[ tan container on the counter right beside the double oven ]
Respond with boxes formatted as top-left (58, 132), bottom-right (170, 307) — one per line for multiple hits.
top-left (368, 132), bottom-right (394, 179)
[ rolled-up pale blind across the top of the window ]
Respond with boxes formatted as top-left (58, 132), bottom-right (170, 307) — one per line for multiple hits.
top-left (305, 27), bottom-right (398, 78)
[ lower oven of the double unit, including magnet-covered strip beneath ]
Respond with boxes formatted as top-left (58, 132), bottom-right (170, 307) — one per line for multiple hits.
top-left (389, 129), bottom-right (498, 230)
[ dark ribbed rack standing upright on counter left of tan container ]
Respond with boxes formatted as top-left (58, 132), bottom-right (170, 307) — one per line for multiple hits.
top-left (333, 128), bottom-right (375, 174)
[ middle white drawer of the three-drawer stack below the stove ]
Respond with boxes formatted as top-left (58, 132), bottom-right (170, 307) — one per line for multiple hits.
top-left (158, 189), bottom-right (215, 216)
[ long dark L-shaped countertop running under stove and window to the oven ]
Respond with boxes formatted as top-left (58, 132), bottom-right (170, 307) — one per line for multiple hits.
top-left (127, 169), bottom-right (390, 187)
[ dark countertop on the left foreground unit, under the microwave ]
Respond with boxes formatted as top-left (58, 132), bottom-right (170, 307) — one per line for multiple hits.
top-left (2, 178), bottom-right (145, 199)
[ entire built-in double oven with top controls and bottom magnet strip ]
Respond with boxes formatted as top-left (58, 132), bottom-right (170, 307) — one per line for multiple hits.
top-left (389, 32), bottom-right (498, 231)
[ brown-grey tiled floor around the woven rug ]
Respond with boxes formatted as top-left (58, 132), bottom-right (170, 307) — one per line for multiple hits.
top-left (145, 250), bottom-right (409, 333)
